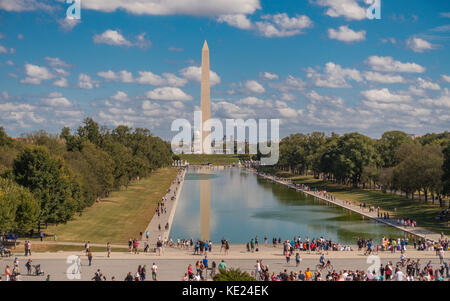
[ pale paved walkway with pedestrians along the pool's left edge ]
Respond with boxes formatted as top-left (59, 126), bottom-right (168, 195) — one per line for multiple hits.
top-left (139, 169), bottom-right (186, 246)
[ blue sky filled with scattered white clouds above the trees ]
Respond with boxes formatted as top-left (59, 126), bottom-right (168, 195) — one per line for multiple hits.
top-left (0, 0), bottom-right (450, 139)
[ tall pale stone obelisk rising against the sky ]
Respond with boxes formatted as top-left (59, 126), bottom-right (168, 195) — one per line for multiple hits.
top-left (200, 41), bottom-right (211, 154)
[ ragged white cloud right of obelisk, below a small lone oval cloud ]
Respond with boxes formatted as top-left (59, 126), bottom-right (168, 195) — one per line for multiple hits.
top-left (306, 62), bottom-right (363, 88)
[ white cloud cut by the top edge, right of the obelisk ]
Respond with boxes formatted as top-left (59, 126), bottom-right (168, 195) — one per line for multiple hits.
top-left (316, 0), bottom-right (366, 20)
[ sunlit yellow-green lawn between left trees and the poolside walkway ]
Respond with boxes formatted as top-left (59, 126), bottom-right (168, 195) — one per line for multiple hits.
top-left (45, 168), bottom-right (177, 244)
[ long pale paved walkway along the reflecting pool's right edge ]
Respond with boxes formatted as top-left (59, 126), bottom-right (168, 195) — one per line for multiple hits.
top-left (255, 169), bottom-right (441, 241)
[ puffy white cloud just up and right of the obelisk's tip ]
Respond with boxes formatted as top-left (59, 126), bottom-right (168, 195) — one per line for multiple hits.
top-left (255, 13), bottom-right (313, 38)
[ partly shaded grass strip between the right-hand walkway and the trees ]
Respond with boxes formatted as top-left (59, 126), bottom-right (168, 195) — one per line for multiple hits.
top-left (258, 169), bottom-right (450, 235)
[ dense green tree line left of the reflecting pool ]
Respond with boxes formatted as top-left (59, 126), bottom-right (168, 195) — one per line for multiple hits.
top-left (0, 118), bottom-right (172, 233)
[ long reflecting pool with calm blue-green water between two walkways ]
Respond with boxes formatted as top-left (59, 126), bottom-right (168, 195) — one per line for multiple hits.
top-left (170, 168), bottom-right (405, 244)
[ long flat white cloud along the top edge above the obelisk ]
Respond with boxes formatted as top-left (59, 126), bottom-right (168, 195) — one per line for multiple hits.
top-left (82, 0), bottom-right (261, 16)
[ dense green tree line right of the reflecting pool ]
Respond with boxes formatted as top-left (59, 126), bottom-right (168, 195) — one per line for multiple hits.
top-left (276, 131), bottom-right (450, 205)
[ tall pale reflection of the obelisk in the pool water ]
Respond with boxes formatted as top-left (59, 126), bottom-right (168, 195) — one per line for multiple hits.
top-left (200, 167), bottom-right (211, 240)
